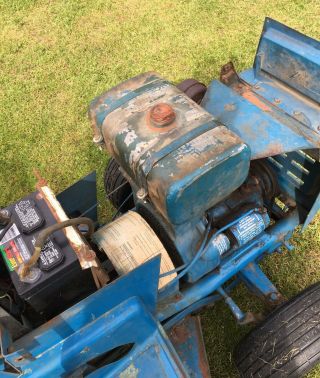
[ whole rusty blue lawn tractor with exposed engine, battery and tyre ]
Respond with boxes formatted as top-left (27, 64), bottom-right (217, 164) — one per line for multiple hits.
top-left (0, 19), bottom-right (320, 378)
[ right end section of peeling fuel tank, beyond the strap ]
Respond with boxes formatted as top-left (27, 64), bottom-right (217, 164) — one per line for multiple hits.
top-left (148, 126), bottom-right (249, 224)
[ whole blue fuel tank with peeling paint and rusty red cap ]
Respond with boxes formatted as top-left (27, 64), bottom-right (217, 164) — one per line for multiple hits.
top-left (89, 73), bottom-right (250, 225)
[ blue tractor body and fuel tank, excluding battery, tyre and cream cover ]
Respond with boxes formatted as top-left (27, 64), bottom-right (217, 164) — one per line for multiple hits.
top-left (0, 19), bottom-right (320, 377)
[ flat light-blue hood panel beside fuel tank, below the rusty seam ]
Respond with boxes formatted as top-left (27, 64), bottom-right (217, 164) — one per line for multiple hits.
top-left (202, 81), bottom-right (320, 159)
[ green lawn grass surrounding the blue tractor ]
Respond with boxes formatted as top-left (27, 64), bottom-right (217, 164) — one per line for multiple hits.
top-left (0, 0), bottom-right (320, 377)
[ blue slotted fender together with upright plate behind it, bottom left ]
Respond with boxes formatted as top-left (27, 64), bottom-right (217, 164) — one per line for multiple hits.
top-left (4, 257), bottom-right (187, 377)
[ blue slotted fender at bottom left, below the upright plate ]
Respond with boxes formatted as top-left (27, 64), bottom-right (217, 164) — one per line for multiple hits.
top-left (7, 297), bottom-right (184, 378)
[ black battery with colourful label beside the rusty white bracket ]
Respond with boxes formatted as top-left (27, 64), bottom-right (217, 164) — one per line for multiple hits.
top-left (0, 191), bottom-right (94, 312)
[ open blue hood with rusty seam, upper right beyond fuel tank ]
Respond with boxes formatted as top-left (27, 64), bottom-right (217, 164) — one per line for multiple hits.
top-left (202, 19), bottom-right (320, 159)
